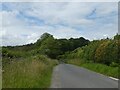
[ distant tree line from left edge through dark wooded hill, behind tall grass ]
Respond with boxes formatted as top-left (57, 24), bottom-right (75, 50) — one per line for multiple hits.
top-left (2, 33), bottom-right (90, 59)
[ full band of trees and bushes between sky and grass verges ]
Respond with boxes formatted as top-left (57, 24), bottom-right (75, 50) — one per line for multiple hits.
top-left (2, 33), bottom-right (120, 65)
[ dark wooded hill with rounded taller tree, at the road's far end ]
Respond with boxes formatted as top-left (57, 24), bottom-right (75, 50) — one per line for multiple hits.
top-left (35, 33), bottom-right (89, 59)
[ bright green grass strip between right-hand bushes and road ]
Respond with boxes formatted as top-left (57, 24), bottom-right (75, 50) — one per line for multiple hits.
top-left (67, 59), bottom-right (120, 78)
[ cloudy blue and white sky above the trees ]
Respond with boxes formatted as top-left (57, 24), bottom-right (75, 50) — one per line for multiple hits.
top-left (0, 2), bottom-right (118, 46)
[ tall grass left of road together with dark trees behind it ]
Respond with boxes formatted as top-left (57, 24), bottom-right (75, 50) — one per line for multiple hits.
top-left (2, 33), bottom-right (89, 88)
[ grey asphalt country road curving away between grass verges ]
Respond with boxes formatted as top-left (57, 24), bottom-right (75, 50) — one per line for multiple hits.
top-left (51, 64), bottom-right (118, 88)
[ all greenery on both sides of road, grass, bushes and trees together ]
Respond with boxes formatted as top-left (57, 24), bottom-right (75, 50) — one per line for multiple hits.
top-left (2, 33), bottom-right (120, 88)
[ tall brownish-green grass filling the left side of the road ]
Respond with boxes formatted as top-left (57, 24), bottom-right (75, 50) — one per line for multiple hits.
top-left (2, 55), bottom-right (57, 88)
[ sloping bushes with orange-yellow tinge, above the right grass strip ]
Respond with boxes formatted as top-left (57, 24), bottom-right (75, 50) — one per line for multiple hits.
top-left (62, 35), bottom-right (120, 65)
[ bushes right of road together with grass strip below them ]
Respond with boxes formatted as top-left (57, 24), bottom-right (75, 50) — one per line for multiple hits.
top-left (61, 35), bottom-right (120, 78)
